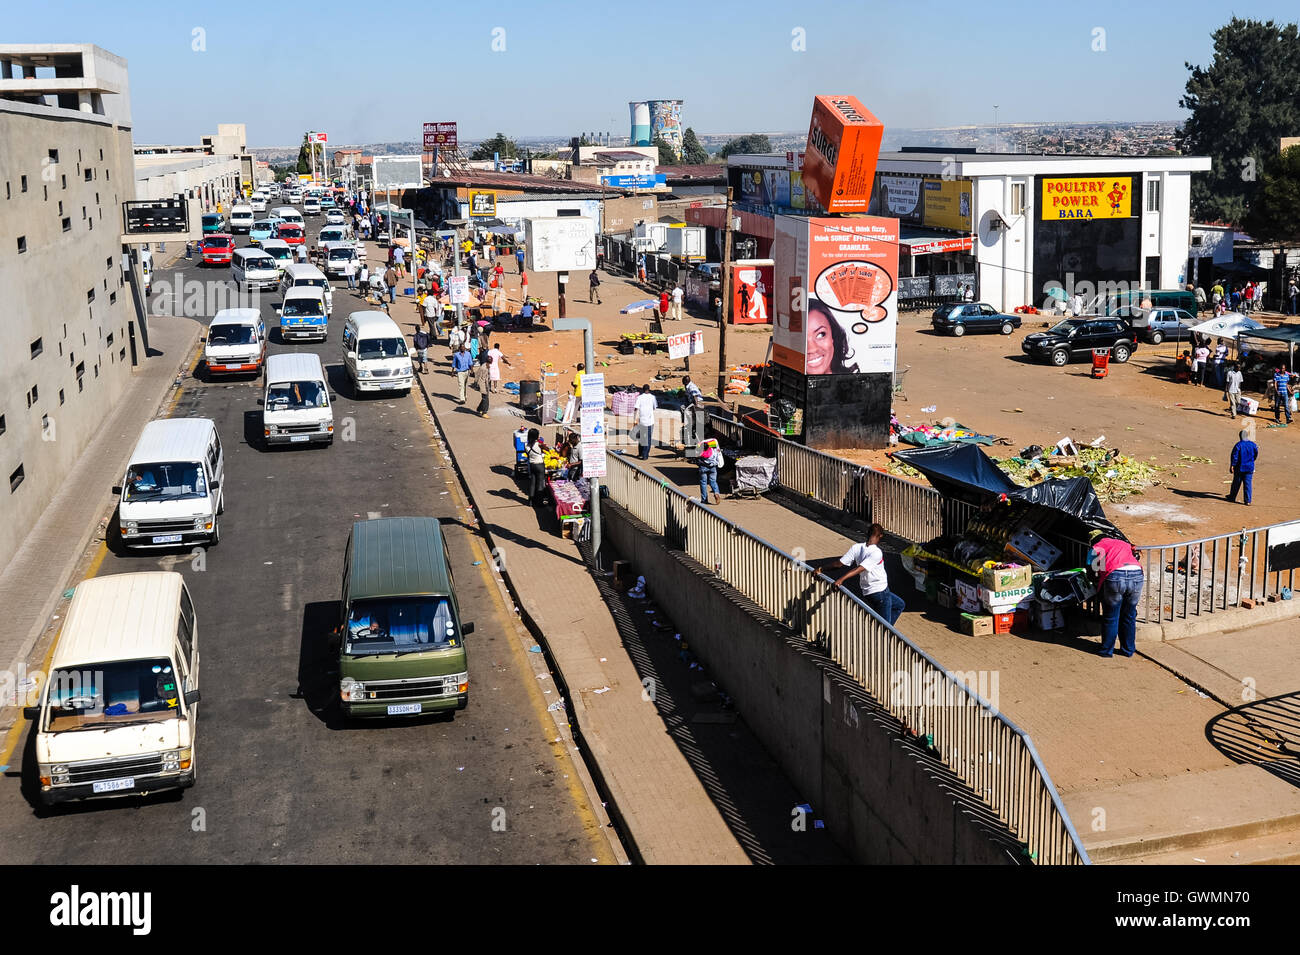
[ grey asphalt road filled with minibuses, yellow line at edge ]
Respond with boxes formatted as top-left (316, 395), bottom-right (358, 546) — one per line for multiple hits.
top-left (0, 207), bottom-right (612, 864)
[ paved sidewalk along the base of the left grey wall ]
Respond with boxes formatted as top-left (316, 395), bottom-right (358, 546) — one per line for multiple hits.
top-left (0, 316), bottom-right (200, 691)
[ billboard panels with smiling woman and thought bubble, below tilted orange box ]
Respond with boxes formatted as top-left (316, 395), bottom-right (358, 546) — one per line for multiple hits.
top-left (772, 216), bottom-right (898, 376)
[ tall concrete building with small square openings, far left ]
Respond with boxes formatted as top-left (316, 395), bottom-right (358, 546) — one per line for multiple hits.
top-left (0, 44), bottom-right (144, 568)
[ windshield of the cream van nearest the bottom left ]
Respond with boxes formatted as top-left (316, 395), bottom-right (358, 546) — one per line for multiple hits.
top-left (47, 657), bottom-right (181, 733)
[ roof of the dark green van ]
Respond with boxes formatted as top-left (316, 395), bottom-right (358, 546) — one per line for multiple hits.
top-left (348, 517), bottom-right (451, 600)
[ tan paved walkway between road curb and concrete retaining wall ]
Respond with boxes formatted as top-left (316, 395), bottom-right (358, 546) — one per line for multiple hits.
top-left (400, 358), bottom-right (749, 864)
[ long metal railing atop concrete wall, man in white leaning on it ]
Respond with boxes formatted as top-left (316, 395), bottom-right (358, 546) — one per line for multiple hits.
top-left (605, 453), bottom-right (1089, 865)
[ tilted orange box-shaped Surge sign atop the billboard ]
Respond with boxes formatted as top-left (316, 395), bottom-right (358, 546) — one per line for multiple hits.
top-left (803, 96), bottom-right (885, 212)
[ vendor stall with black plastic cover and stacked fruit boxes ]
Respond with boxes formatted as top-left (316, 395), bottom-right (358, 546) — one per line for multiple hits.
top-left (896, 444), bottom-right (1125, 635)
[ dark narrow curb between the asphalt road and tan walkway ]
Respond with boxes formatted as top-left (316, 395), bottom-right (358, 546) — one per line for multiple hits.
top-left (415, 374), bottom-right (644, 864)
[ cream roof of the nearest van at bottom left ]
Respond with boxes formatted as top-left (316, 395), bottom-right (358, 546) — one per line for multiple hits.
top-left (53, 570), bottom-right (181, 669)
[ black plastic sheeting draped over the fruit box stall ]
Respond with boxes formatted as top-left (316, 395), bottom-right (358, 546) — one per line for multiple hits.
top-left (893, 444), bottom-right (1127, 541)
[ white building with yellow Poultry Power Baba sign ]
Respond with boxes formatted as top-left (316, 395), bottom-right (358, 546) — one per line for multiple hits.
top-left (722, 148), bottom-right (1210, 311)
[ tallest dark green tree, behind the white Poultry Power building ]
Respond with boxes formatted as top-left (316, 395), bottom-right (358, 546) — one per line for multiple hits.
top-left (1178, 17), bottom-right (1300, 222)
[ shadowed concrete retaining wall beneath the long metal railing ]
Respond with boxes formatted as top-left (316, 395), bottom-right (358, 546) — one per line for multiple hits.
top-left (601, 500), bottom-right (1019, 864)
